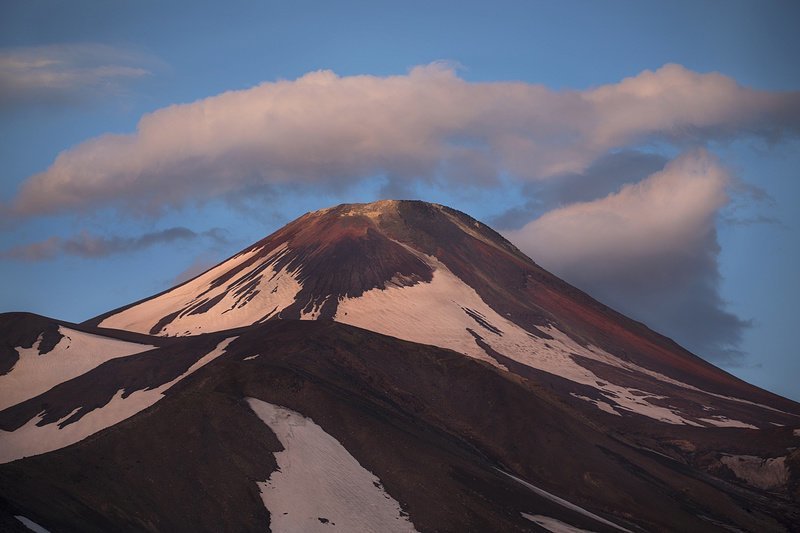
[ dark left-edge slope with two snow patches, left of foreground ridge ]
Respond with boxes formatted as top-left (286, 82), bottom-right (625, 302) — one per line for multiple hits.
top-left (0, 313), bottom-right (224, 464)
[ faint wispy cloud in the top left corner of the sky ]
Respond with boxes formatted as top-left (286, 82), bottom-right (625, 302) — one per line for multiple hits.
top-left (0, 44), bottom-right (158, 109)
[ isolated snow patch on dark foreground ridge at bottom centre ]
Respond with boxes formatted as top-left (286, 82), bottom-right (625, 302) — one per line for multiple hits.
top-left (247, 398), bottom-right (415, 533)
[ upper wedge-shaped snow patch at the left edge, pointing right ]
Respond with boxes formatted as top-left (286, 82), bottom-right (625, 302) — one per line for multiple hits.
top-left (0, 326), bottom-right (155, 410)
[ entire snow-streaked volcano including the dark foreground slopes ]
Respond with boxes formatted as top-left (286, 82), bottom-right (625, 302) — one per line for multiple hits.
top-left (0, 201), bottom-right (800, 532)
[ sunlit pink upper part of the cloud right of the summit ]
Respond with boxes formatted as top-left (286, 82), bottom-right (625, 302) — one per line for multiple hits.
top-left (507, 150), bottom-right (730, 277)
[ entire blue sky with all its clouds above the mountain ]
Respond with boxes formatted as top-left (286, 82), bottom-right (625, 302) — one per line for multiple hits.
top-left (0, 1), bottom-right (800, 399)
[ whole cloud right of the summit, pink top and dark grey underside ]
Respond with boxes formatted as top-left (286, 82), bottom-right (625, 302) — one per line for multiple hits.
top-left (506, 150), bottom-right (748, 363)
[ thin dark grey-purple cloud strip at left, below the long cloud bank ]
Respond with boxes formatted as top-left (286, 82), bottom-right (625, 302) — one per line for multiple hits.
top-left (0, 227), bottom-right (228, 261)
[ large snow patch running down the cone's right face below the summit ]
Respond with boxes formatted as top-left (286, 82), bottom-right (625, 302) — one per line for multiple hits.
top-left (335, 256), bottom-right (701, 426)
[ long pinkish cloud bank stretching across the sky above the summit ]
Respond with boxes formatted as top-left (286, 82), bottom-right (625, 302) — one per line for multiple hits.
top-left (11, 64), bottom-right (800, 216)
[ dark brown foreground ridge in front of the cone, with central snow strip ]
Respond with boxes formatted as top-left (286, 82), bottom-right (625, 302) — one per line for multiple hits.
top-left (0, 321), bottom-right (798, 532)
